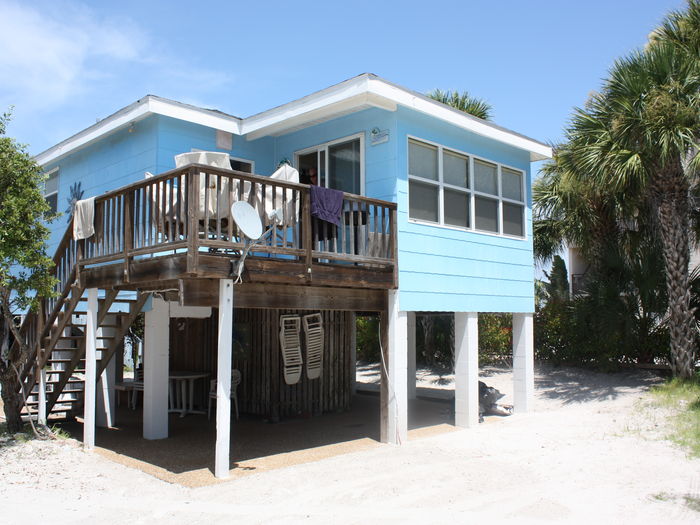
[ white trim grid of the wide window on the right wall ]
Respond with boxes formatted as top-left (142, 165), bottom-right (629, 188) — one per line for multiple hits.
top-left (406, 135), bottom-right (527, 240)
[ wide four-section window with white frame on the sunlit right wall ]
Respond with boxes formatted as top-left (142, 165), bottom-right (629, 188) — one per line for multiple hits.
top-left (408, 139), bottom-right (525, 237)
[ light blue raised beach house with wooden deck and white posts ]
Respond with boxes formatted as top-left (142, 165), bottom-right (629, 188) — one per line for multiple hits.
top-left (16, 74), bottom-right (551, 477)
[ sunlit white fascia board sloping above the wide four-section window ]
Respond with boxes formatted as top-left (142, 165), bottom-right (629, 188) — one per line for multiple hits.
top-left (368, 79), bottom-right (552, 161)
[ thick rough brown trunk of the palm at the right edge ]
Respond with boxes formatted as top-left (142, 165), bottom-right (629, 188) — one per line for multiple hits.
top-left (651, 170), bottom-right (696, 378)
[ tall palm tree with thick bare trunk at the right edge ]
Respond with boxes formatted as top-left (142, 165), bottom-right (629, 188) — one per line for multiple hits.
top-left (569, 38), bottom-right (700, 377)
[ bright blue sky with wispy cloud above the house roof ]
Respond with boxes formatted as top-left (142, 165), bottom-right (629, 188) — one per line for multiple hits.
top-left (0, 0), bottom-right (685, 154)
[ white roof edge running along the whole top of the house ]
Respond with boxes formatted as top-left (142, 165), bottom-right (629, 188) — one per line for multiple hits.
top-left (35, 73), bottom-right (552, 165)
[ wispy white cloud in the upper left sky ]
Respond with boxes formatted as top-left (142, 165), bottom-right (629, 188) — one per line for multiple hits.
top-left (0, 0), bottom-right (147, 110)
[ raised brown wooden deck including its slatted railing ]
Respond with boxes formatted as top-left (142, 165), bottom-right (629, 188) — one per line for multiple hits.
top-left (53, 165), bottom-right (398, 311)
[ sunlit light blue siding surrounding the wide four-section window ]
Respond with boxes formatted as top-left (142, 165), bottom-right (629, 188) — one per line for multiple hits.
top-left (394, 107), bottom-right (534, 312)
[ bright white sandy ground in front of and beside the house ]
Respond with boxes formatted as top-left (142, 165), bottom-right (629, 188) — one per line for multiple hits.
top-left (0, 367), bottom-right (700, 525)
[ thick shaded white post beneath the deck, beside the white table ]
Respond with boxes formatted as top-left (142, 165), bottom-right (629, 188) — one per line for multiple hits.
top-left (143, 297), bottom-right (170, 439)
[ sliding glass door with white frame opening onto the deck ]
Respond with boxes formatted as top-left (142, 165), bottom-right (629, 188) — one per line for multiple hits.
top-left (295, 136), bottom-right (363, 195)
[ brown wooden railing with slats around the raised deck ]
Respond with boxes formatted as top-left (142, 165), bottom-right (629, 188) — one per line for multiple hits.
top-left (76, 164), bottom-right (396, 271)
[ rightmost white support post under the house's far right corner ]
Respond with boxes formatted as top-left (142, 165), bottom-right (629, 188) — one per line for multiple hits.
top-left (513, 313), bottom-right (535, 413)
